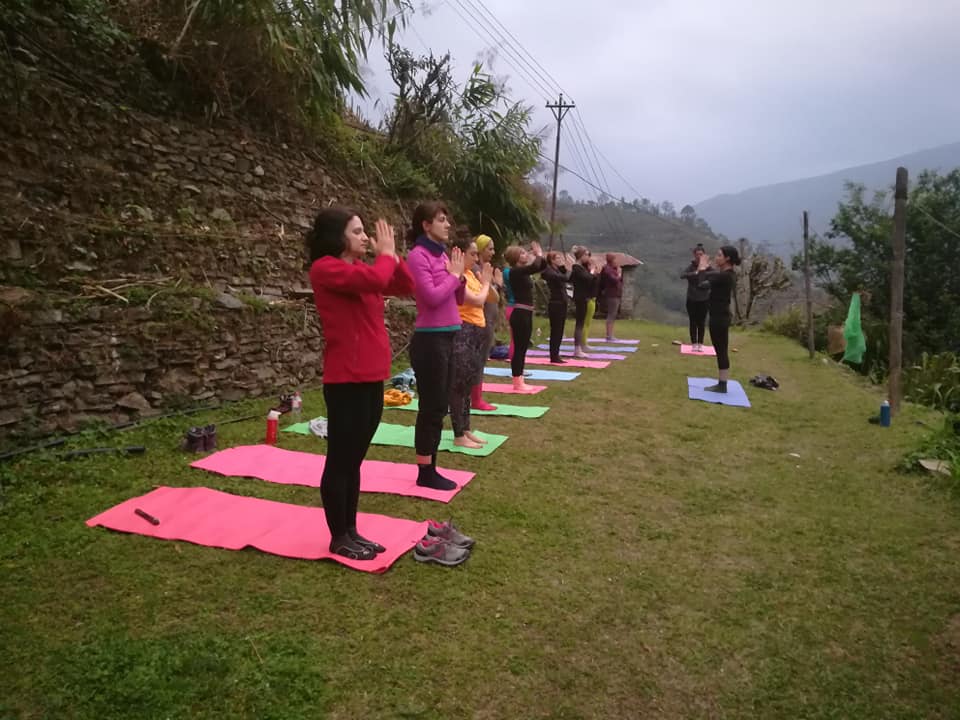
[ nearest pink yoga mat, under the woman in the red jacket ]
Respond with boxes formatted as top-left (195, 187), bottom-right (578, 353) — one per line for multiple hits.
top-left (87, 487), bottom-right (427, 573)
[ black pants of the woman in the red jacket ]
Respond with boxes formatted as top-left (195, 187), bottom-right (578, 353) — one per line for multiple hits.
top-left (320, 382), bottom-right (383, 538)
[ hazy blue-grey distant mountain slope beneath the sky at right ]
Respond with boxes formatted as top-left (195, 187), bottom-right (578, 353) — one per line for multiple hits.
top-left (694, 142), bottom-right (960, 256)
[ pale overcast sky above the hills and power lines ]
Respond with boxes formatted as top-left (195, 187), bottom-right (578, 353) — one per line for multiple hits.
top-left (352, 0), bottom-right (960, 208)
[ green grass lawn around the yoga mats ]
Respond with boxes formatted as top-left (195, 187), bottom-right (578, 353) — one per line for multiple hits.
top-left (0, 323), bottom-right (960, 720)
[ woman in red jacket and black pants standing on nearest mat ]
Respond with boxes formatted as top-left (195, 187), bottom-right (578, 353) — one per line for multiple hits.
top-left (306, 208), bottom-right (413, 560)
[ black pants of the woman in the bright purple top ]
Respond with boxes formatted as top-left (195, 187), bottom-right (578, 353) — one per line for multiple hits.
top-left (410, 331), bottom-right (459, 456)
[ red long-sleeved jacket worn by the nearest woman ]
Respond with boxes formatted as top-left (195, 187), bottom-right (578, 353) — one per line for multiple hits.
top-left (310, 255), bottom-right (413, 385)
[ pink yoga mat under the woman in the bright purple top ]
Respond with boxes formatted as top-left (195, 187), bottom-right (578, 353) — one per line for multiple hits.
top-left (190, 445), bottom-right (475, 502)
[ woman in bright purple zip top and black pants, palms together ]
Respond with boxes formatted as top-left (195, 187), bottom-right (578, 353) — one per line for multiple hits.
top-left (407, 201), bottom-right (465, 490)
